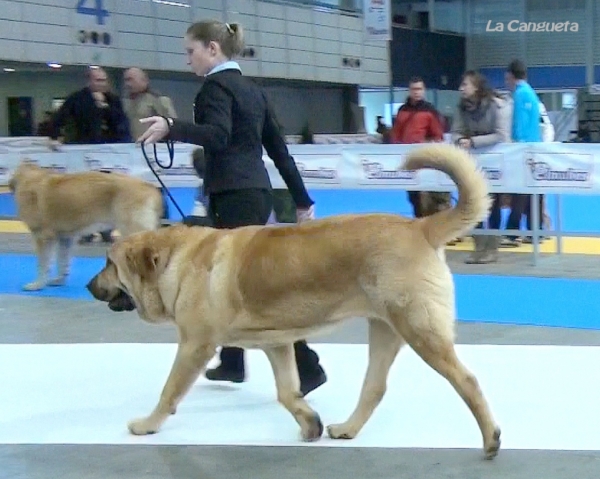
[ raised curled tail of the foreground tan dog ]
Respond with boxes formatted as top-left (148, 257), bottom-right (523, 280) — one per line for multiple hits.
top-left (403, 143), bottom-right (491, 248)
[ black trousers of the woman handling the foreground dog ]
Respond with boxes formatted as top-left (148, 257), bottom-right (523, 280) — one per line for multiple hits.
top-left (208, 189), bottom-right (319, 376)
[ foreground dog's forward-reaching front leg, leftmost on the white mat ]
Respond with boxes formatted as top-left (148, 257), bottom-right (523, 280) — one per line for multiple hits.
top-left (128, 338), bottom-right (215, 435)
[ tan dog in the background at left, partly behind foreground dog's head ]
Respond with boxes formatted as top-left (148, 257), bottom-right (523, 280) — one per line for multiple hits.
top-left (9, 160), bottom-right (163, 291)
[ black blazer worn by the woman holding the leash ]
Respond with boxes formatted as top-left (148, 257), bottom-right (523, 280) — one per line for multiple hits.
top-left (169, 69), bottom-right (314, 208)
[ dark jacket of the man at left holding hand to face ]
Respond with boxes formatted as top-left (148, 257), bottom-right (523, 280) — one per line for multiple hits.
top-left (49, 87), bottom-right (132, 144)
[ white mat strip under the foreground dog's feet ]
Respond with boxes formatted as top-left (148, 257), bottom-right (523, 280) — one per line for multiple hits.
top-left (0, 344), bottom-right (600, 450)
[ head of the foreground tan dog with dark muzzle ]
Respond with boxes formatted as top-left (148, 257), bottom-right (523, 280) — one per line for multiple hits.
top-left (87, 232), bottom-right (170, 323)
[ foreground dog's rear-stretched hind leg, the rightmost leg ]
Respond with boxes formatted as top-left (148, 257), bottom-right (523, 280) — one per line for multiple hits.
top-left (396, 296), bottom-right (500, 459)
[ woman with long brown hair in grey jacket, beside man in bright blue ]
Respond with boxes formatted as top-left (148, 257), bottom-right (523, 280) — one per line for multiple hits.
top-left (451, 70), bottom-right (512, 264)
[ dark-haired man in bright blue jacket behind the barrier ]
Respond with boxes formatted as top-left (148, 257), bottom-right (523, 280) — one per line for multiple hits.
top-left (502, 60), bottom-right (542, 247)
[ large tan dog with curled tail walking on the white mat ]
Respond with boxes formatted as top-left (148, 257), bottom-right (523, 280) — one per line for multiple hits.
top-left (88, 144), bottom-right (500, 459)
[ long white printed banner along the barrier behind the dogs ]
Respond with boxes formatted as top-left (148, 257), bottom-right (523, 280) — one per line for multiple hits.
top-left (0, 138), bottom-right (600, 195)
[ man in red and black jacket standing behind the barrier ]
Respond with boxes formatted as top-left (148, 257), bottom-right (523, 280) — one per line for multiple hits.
top-left (390, 77), bottom-right (448, 218)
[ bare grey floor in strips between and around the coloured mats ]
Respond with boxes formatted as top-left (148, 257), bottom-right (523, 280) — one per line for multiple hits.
top-left (0, 235), bottom-right (600, 479)
